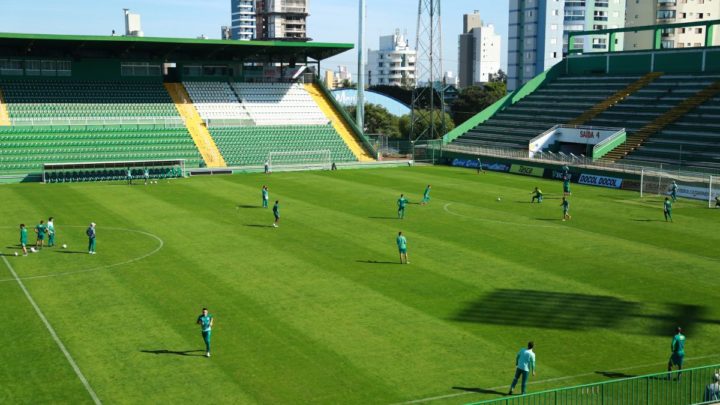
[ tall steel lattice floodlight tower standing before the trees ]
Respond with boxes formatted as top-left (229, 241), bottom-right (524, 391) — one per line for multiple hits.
top-left (410, 0), bottom-right (445, 142)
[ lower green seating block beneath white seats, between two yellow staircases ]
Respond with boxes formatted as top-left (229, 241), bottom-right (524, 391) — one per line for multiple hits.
top-left (210, 125), bottom-right (357, 166)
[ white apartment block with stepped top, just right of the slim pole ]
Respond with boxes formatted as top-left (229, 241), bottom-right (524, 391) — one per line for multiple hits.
top-left (365, 30), bottom-right (417, 87)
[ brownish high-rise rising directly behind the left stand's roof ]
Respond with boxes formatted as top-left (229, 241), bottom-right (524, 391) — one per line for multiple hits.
top-left (255, 0), bottom-right (310, 41)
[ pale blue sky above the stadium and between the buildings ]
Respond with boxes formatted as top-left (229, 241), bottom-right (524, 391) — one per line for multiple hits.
top-left (0, 0), bottom-right (508, 78)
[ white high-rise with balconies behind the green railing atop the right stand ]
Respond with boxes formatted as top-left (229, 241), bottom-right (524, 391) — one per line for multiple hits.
top-left (563, 0), bottom-right (624, 54)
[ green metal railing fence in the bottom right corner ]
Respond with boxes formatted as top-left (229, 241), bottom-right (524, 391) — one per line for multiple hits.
top-left (472, 365), bottom-right (720, 405)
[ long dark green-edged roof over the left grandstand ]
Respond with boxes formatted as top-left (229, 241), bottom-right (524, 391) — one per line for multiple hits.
top-left (0, 33), bottom-right (353, 61)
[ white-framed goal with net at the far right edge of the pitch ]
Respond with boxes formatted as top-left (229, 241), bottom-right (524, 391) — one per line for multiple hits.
top-left (640, 169), bottom-right (720, 208)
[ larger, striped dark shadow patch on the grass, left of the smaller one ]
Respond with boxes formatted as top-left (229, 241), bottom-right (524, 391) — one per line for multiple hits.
top-left (453, 289), bottom-right (640, 330)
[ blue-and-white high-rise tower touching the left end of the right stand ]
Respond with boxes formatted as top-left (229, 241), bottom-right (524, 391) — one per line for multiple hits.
top-left (508, 0), bottom-right (564, 90)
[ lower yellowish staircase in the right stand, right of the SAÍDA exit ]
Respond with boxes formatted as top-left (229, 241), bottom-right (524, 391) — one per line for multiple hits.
top-left (601, 81), bottom-right (720, 162)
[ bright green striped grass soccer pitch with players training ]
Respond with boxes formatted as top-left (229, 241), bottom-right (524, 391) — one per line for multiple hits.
top-left (0, 167), bottom-right (720, 404)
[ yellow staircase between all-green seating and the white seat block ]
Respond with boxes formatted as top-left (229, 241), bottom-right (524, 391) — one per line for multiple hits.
top-left (165, 83), bottom-right (227, 167)
